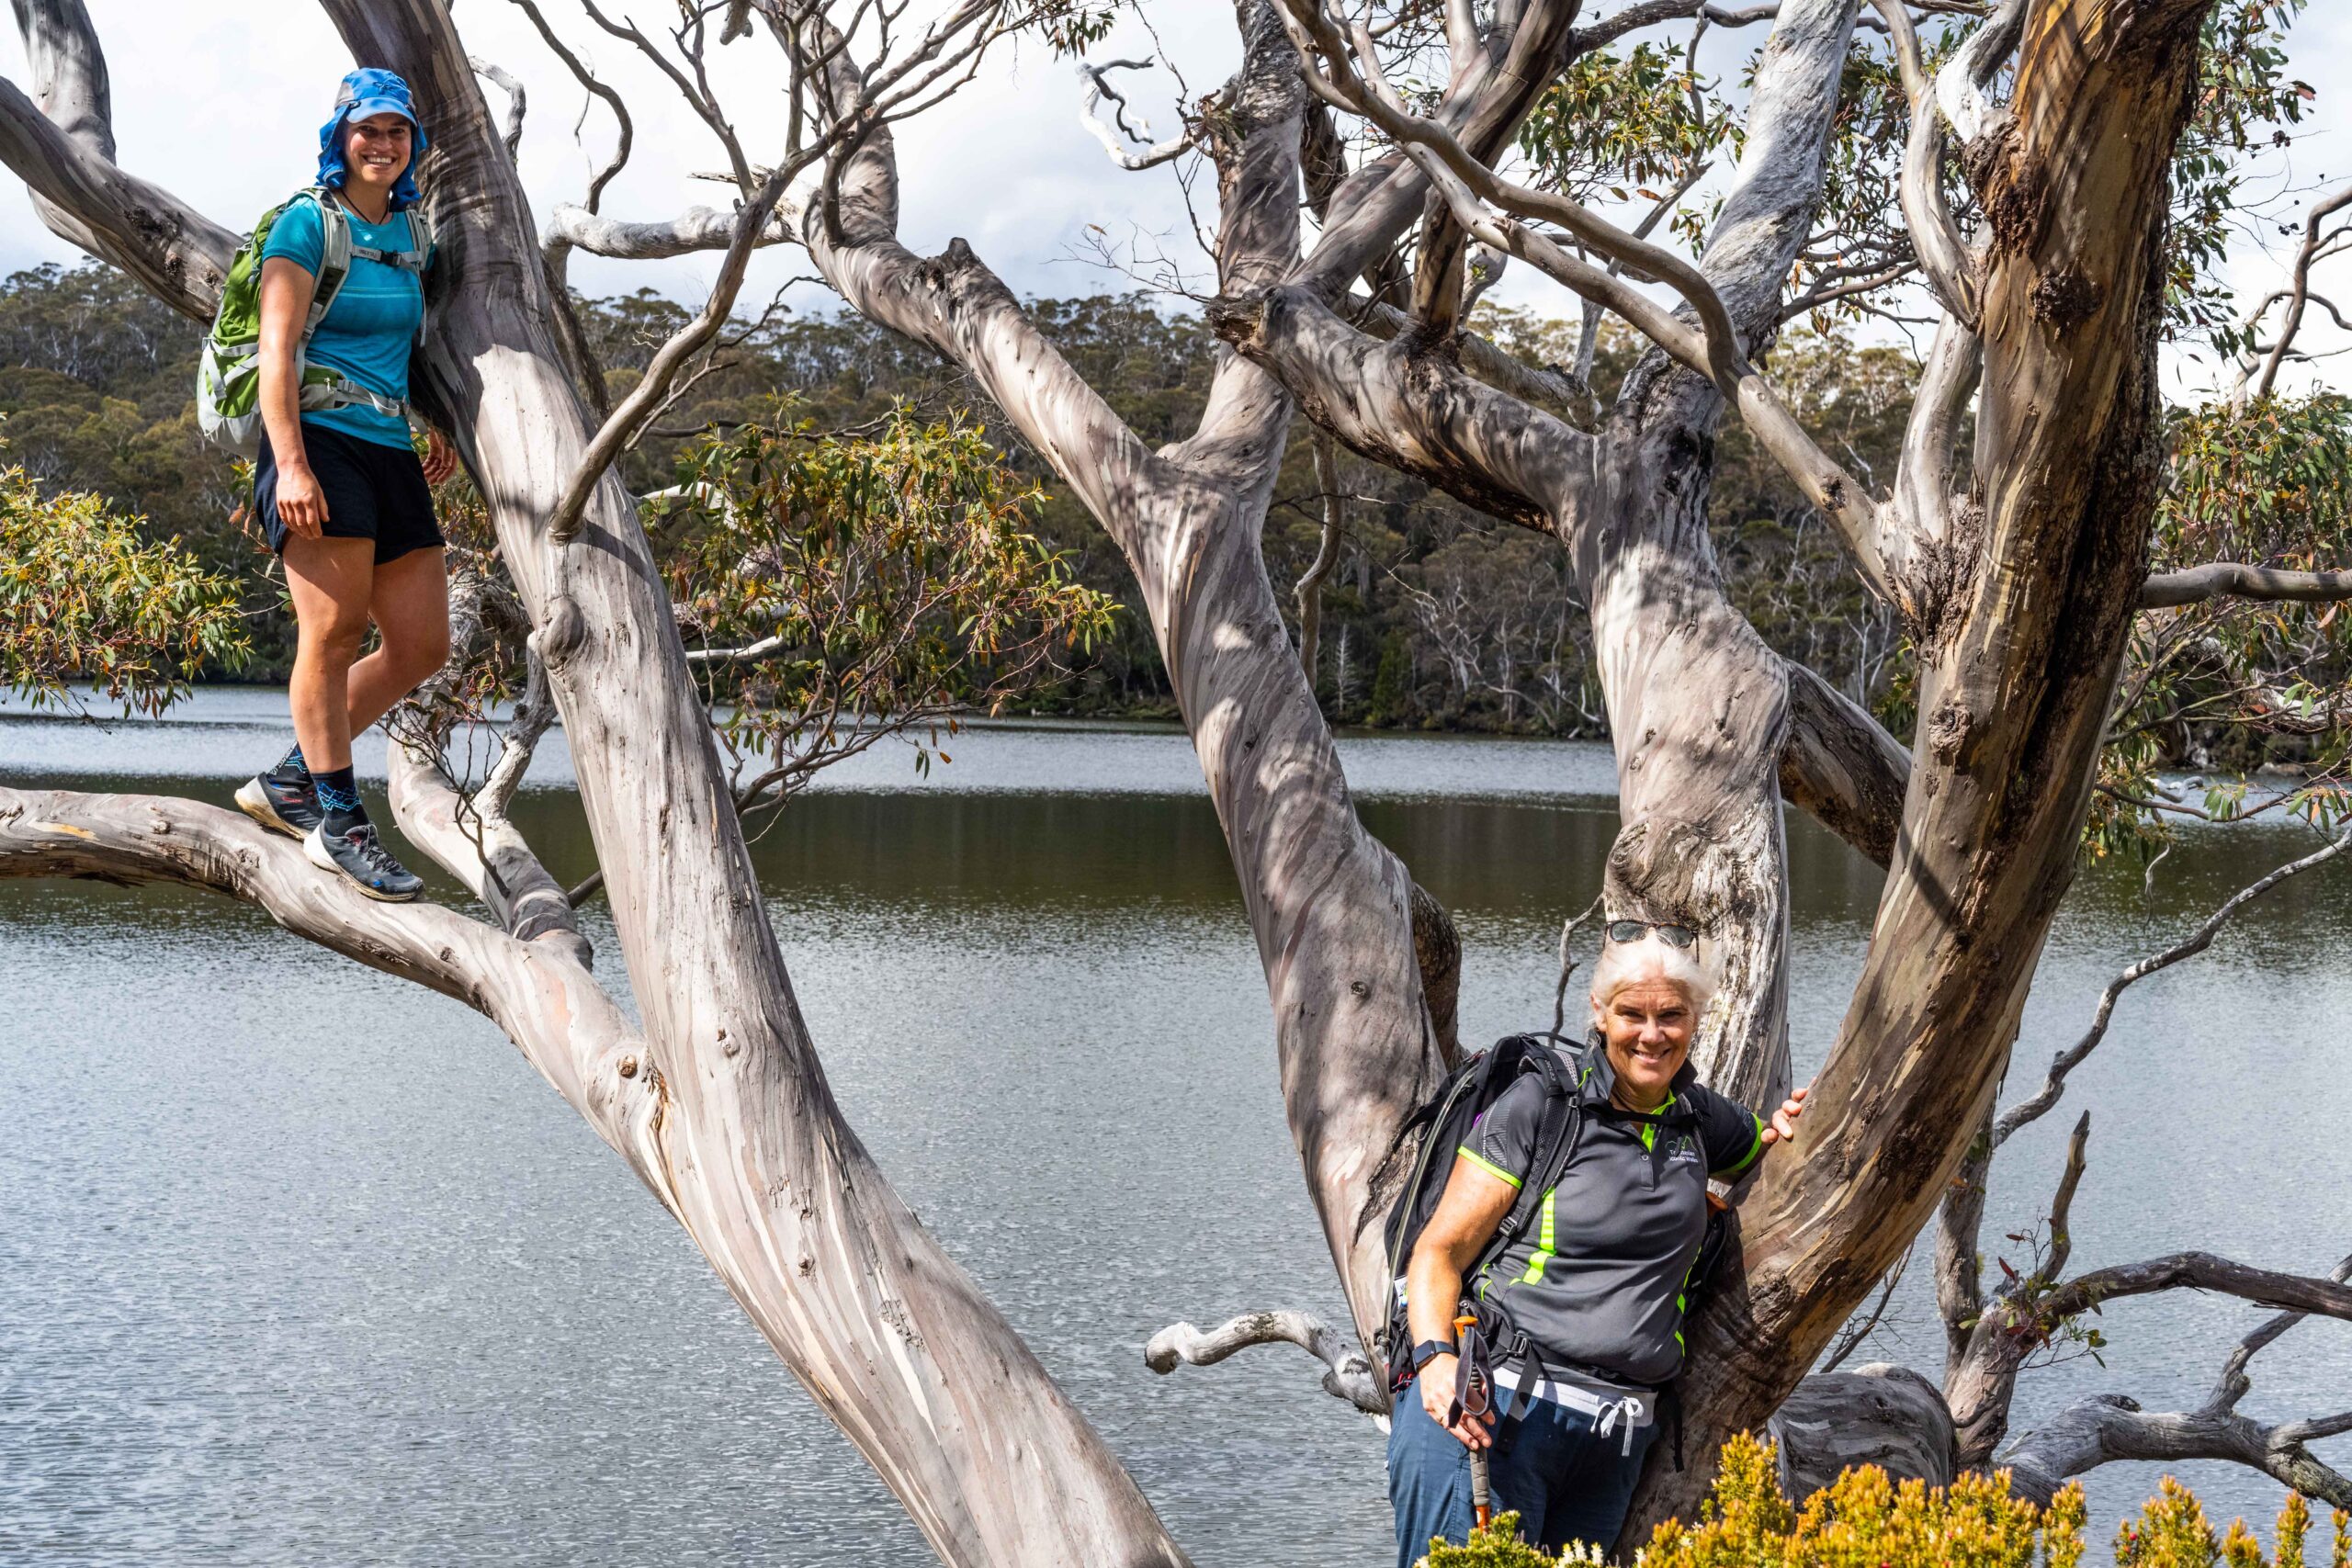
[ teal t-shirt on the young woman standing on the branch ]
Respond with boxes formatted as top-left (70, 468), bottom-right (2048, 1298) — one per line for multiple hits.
top-left (261, 202), bottom-right (425, 446)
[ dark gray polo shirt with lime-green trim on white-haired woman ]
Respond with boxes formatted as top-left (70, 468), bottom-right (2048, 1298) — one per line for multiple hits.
top-left (1461, 1043), bottom-right (1764, 1387)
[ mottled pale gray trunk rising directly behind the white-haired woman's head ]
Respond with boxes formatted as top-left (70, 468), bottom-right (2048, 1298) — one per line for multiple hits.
top-left (1559, 0), bottom-right (1853, 1105)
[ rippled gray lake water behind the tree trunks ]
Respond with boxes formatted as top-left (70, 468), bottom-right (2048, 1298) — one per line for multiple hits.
top-left (0, 691), bottom-right (2352, 1568)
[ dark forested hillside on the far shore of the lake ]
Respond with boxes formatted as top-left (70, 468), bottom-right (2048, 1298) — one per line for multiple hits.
top-left (0, 264), bottom-right (1917, 736)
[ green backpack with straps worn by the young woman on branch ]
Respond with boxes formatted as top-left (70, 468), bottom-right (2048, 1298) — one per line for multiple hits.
top-left (195, 186), bottom-right (433, 456)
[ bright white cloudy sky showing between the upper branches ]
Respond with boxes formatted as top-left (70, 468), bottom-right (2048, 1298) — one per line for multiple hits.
top-left (0, 0), bottom-right (2352, 401)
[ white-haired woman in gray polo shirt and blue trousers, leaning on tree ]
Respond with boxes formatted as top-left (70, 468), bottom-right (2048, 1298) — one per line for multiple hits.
top-left (1387, 919), bottom-right (1806, 1568)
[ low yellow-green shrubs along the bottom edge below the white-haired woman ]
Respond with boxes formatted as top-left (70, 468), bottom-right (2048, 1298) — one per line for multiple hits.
top-left (1420, 1434), bottom-right (2352, 1568)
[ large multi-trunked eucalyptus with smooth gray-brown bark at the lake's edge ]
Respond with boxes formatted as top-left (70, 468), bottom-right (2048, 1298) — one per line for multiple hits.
top-left (0, 0), bottom-right (2352, 1563)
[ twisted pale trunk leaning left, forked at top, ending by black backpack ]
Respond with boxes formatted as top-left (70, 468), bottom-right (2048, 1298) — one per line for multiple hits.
top-left (805, 0), bottom-right (1458, 1345)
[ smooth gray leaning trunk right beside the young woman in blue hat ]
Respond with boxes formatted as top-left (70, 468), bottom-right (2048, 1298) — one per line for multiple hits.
top-left (0, 0), bottom-right (1183, 1568)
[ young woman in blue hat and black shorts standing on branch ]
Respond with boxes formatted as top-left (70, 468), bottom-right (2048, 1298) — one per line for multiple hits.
top-left (238, 71), bottom-right (457, 900)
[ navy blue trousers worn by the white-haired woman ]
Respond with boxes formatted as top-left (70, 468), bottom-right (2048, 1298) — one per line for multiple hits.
top-left (1387, 1380), bottom-right (1658, 1568)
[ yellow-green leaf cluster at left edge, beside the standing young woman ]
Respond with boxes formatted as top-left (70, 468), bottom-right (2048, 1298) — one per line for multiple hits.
top-left (0, 434), bottom-right (252, 712)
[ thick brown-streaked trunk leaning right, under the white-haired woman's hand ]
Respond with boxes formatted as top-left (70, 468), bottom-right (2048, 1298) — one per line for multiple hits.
top-left (1628, 0), bottom-right (2209, 1540)
